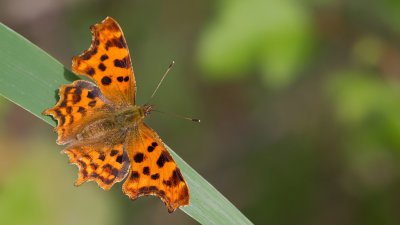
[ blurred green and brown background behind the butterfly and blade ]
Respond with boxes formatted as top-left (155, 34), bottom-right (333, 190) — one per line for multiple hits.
top-left (0, 0), bottom-right (400, 225)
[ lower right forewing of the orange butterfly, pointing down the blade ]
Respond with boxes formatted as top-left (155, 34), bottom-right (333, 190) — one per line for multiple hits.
top-left (123, 123), bottom-right (189, 212)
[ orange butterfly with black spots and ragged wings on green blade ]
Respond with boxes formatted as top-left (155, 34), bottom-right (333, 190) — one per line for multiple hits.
top-left (42, 17), bottom-right (189, 213)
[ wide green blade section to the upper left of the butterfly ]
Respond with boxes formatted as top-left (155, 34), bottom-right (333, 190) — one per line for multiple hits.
top-left (0, 23), bottom-right (78, 126)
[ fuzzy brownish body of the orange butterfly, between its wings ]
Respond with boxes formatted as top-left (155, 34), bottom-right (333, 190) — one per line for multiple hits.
top-left (77, 105), bottom-right (154, 140)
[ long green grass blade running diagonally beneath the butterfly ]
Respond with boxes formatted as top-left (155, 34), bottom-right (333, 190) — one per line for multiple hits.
top-left (0, 23), bottom-right (251, 224)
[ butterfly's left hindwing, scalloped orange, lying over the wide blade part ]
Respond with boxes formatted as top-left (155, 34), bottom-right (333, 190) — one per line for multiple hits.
top-left (42, 80), bottom-right (114, 144)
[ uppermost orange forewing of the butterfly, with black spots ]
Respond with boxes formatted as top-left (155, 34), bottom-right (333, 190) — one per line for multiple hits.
top-left (72, 17), bottom-right (136, 105)
